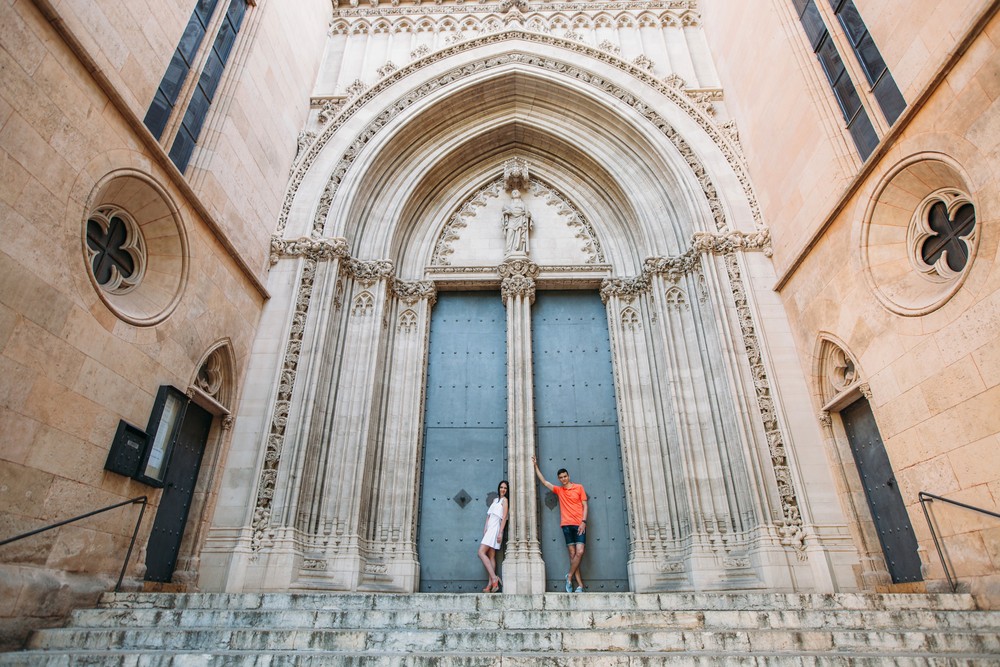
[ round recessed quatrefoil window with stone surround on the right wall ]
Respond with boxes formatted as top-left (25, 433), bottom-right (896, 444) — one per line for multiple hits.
top-left (861, 154), bottom-right (979, 316)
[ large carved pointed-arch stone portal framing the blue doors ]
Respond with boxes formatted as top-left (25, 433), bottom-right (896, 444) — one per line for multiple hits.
top-left (205, 31), bottom-right (852, 593)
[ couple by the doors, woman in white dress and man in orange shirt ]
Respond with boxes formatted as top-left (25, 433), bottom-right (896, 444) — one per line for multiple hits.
top-left (479, 456), bottom-right (588, 593)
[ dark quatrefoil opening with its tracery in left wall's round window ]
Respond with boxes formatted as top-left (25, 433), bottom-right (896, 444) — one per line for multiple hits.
top-left (87, 206), bottom-right (146, 294)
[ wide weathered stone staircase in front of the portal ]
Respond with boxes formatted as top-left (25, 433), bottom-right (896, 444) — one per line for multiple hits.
top-left (0, 593), bottom-right (1000, 667)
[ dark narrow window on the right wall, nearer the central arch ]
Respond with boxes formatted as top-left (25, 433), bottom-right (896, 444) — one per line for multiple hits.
top-left (792, 0), bottom-right (878, 160)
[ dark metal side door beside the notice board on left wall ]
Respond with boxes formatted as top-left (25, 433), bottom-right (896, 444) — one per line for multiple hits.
top-left (146, 403), bottom-right (212, 582)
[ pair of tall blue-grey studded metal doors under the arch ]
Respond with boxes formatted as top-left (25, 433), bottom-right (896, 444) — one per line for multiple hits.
top-left (418, 291), bottom-right (628, 592)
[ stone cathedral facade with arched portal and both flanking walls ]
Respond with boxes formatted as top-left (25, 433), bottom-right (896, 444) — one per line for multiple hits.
top-left (0, 0), bottom-right (1000, 648)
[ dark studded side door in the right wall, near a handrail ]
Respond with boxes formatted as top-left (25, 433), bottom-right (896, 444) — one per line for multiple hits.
top-left (840, 398), bottom-right (923, 584)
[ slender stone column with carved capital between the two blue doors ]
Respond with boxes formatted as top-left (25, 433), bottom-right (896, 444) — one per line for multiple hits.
top-left (497, 259), bottom-right (545, 595)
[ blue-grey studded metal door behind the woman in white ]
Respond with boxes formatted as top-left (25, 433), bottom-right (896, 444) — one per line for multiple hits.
top-left (417, 292), bottom-right (507, 592)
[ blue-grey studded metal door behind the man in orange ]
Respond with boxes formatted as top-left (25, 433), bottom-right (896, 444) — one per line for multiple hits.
top-left (531, 291), bottom-right (628, 591)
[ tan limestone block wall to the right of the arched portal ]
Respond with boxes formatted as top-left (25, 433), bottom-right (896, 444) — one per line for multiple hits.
top-left (703, 0), bottom-right (1000, 606)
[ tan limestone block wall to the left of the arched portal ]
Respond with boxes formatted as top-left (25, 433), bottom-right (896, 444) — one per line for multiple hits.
top-left (0, 0), bottom-right (329, 646)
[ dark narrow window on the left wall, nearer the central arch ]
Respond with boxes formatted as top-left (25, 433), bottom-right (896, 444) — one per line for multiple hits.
top-left (170, 0), bottom-right (247, 171)
